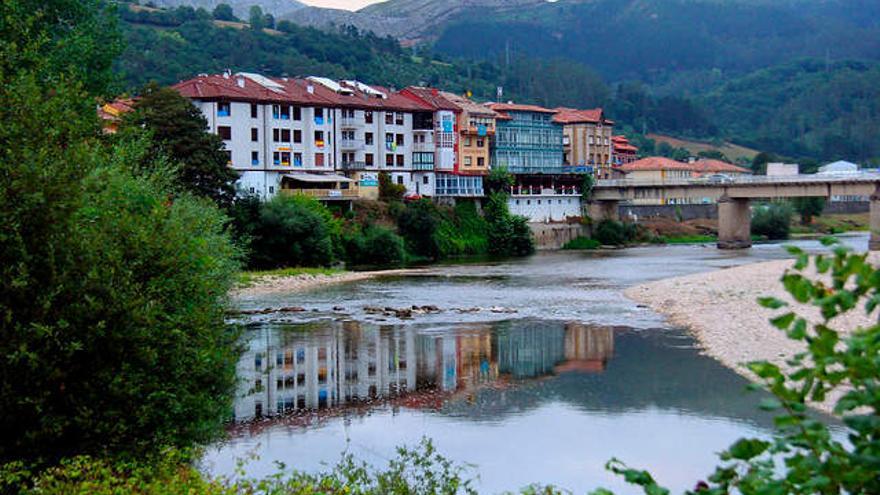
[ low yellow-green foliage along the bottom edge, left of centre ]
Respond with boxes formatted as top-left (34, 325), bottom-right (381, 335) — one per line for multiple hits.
top-left (0, 440), bottom-right (477, 495)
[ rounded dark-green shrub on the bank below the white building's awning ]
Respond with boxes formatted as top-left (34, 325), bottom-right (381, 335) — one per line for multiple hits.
top-left (250, 195), bottom-right (338, 269)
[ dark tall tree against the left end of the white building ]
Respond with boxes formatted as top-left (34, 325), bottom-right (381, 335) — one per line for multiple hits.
top-left (121, 84), bottom-right (238, 208)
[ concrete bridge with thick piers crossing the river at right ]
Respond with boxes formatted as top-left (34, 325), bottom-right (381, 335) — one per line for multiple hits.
top-left (589, 173), bottom-right (880, 251)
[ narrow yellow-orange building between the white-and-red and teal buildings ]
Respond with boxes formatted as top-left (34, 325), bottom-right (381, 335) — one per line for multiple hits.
top-left (440, 91), bottom-right (498, 175)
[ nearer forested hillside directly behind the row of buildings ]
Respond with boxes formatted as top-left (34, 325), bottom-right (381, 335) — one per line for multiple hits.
top-left (118, 0), bottom-right (880, 162)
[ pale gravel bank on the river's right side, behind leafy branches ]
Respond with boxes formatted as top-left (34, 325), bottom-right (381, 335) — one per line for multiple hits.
top-left (625, 257), bottom-right (878, 412)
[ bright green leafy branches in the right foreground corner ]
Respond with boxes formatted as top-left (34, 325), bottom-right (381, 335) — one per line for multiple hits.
top-left (599, 240), bottom-right (880, 495)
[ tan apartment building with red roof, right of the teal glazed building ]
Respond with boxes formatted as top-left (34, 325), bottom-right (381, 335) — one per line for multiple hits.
top-left (553, 107), bottom-right (614, 179)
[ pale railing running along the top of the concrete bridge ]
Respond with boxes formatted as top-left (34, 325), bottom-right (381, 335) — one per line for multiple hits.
top-left (596, 172), bottom-right (880, 188)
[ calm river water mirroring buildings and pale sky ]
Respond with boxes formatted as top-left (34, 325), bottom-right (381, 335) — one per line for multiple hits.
top-left (204, 236), bottom-right (867, 493)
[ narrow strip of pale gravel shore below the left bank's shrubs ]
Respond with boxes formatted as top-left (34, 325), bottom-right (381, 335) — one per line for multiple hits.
top-left (229, 268), bottom-right (424, 300)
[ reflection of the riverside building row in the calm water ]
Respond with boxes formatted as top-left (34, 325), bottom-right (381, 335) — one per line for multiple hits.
top-left (235, 320), bottom-right (614, 421)
